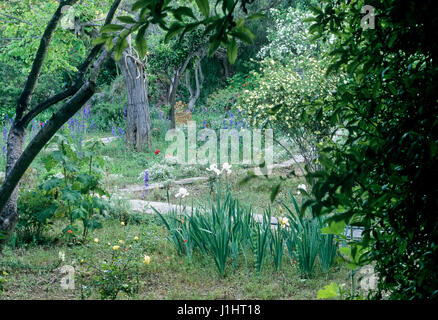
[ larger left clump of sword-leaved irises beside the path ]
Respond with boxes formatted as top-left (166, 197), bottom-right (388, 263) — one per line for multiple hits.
top-left (154, 180), bottom-right (256, 276)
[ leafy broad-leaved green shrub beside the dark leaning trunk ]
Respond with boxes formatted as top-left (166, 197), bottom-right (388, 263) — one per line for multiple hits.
top-left (38, 135), bottom-right (108, 240)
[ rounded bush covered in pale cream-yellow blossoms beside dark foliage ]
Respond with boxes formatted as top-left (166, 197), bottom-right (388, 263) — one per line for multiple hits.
top-left (237, 56), bottom-right (340, 171)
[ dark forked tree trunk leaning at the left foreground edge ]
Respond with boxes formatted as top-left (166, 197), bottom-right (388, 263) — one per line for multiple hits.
top-left (0, 0), bottom-right (121, 250)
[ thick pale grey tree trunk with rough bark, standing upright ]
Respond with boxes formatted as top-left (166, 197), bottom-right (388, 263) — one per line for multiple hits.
top-left (118, 49), bottom-right (152, 151)
